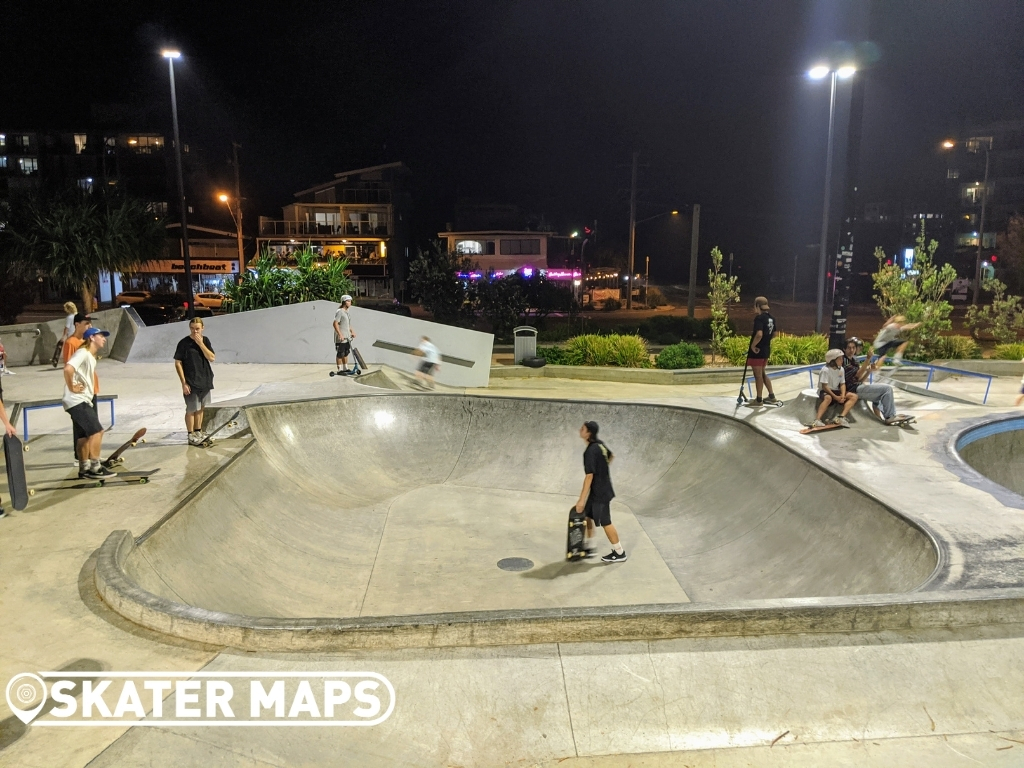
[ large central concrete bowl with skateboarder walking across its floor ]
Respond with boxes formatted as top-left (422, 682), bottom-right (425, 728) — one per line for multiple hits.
top-left (95, 393), bottom-right (943, 650)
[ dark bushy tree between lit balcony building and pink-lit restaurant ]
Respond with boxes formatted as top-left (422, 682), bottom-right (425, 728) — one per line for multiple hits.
top-left (409, 242), bottom-right (476, 325)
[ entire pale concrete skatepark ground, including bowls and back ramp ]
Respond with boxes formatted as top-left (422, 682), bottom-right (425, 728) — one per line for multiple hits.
top-left (0, 307), bottom-right (1024, 766)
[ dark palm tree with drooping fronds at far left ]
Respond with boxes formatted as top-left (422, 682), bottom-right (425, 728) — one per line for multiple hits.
top-left (7, 189), bottom-right (167, 307)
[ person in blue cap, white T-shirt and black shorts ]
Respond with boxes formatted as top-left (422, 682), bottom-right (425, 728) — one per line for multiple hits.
top-left (63, 328), bottom-right (114, 480)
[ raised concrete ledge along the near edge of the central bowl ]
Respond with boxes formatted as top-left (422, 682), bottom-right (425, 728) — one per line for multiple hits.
top-left (95, 530), bottom-right (1024, 652)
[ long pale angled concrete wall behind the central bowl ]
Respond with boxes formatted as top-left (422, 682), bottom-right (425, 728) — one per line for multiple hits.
top-left (127, 301), bottom-right (494, 387)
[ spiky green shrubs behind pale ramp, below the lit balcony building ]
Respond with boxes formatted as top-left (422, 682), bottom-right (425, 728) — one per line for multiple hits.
top-left (224, 245), bottom-right (355, 312)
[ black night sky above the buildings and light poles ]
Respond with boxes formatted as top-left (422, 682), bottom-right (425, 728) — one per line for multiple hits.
top-left (0, 0), bottom-right (1024, 290)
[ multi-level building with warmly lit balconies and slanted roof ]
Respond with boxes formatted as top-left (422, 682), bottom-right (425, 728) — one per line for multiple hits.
top-left (257, 163), bottom-right (411, 298)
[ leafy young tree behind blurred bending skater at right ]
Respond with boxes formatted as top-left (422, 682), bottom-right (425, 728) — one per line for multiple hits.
top-left (871, 222), bottom-right (956, 358)
